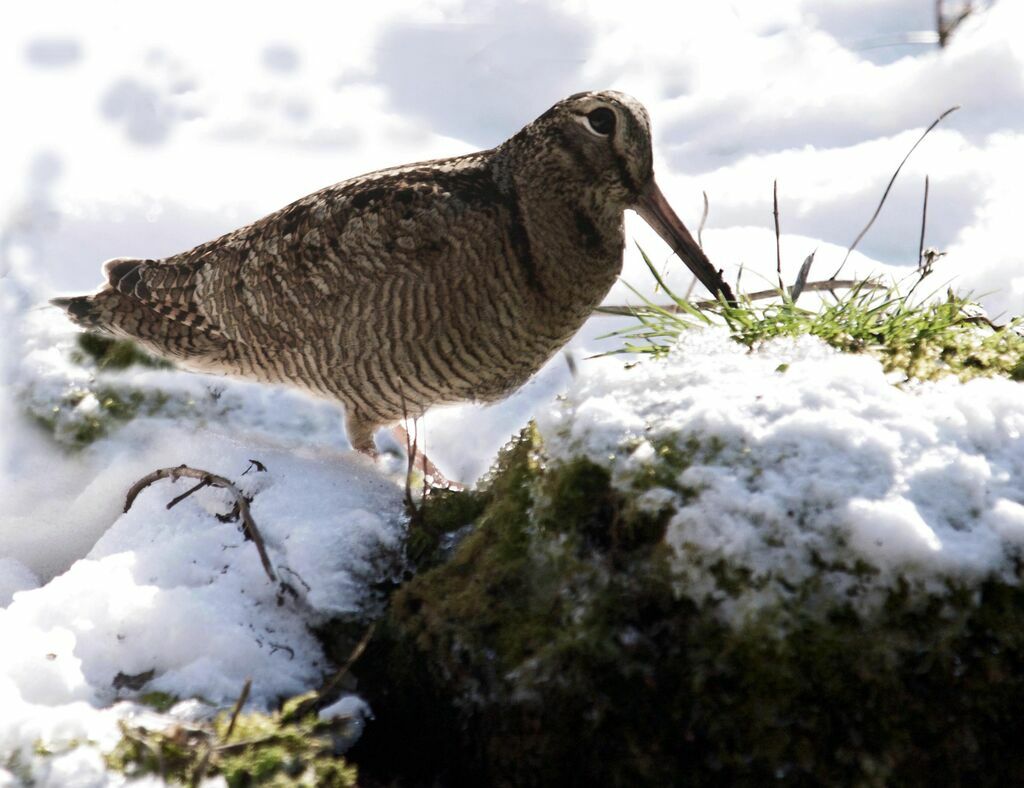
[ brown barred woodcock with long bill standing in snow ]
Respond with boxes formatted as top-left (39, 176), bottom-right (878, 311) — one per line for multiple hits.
top-left (51, 90), bottom-right (733, 455)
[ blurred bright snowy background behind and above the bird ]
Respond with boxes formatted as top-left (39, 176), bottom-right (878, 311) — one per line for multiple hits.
top-left (0, 0), bottom-right (1024, 470)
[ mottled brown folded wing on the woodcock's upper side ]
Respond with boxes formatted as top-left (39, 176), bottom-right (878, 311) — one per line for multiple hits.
top-left (187, 157), bottom-right (500, 343)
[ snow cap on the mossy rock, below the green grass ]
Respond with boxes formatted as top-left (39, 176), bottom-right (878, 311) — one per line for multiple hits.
top-left (539, 329), bottom-right (1024, 623)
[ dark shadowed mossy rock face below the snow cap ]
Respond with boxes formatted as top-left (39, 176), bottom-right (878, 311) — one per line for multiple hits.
top-left (348, 431), bottom-right (1024, 786)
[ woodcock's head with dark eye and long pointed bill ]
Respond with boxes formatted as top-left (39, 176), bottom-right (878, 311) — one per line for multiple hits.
top-left (506, 90), bottom-right (733, 301)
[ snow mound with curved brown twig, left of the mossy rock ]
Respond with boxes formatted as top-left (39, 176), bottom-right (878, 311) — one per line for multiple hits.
top-left (0, 423), bottom-right (403, 785)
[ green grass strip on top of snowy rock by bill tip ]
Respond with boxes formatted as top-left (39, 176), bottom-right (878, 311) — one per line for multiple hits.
top-left (608, 243), bottom-right (1024, 381)
